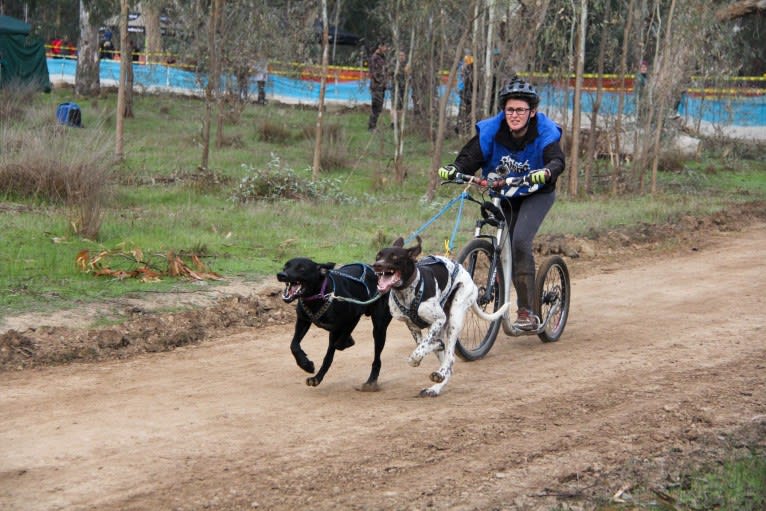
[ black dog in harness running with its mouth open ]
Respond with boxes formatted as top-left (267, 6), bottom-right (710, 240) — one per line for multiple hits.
top-left (277, 257), bottom-right (391, 391)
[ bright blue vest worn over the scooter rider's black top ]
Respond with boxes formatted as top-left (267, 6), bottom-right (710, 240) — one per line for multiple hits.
top-left (476, 111), bottom-right (561, 197)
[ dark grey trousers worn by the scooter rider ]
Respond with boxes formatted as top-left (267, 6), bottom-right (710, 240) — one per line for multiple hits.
top-left (503, 191), bottom-right (556, 311)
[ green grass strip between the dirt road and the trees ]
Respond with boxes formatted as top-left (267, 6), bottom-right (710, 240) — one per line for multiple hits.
top-left (0, 89), bottom-right (766, 318)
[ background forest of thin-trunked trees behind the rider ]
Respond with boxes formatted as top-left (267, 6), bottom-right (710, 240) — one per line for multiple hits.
top-left (0, 0), bottom-right (766, 196)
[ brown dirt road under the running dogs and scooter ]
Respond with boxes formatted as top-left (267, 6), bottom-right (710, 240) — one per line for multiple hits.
top-left (0, 223), bottom-right (766, 511)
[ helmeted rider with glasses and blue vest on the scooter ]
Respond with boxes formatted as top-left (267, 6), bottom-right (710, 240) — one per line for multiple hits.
top-left (438, 78), bottom-right (565, 330)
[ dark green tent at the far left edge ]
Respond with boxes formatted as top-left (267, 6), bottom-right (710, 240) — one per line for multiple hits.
top-left (0, 15), bottom-right (51, 92)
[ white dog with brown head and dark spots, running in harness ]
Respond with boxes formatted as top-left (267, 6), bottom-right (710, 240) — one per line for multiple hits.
top-left (373, 237), bottom-right (508, 397)
